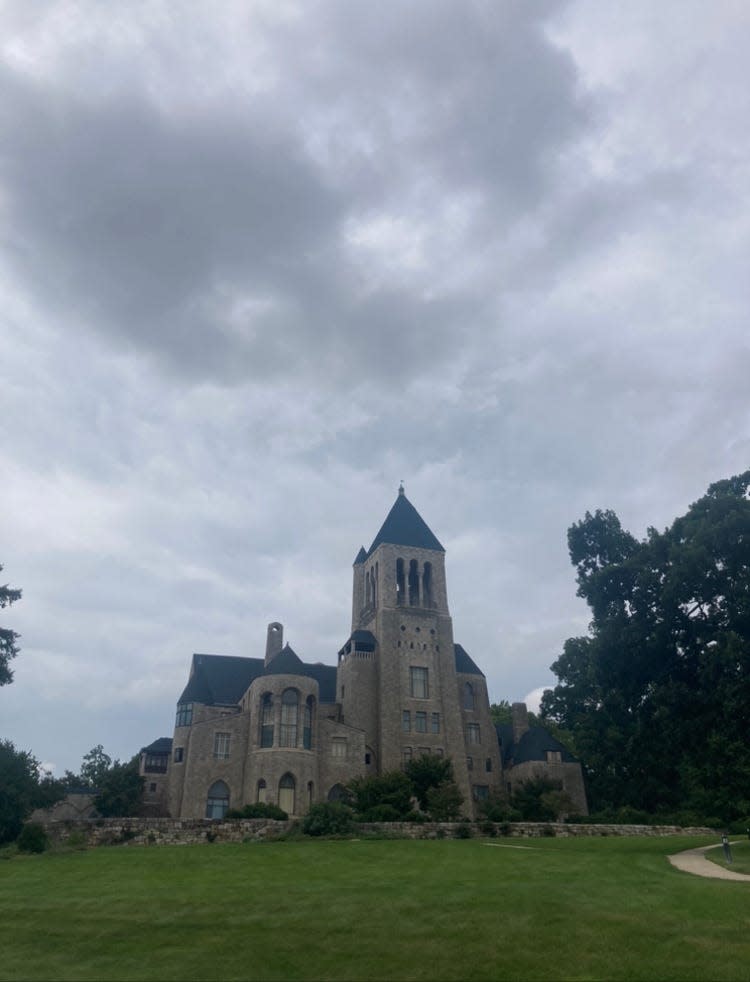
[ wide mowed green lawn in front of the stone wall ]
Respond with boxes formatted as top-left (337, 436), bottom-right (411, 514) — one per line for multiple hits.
top-left (0, 838), bottom-right (750, 982)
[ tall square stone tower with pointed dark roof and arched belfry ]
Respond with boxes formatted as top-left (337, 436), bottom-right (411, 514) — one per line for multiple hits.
top-left (339, 487), bottom-right (470, 799)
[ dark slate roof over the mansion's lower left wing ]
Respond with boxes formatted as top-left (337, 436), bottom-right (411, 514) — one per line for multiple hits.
top-left (178, 645), bottom-right (336, 706)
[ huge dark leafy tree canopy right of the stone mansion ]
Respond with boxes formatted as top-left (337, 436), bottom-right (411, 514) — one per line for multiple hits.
top-left (542, 471), bottom-right (750, 819)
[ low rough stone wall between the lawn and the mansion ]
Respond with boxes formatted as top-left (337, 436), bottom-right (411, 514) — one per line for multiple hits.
top-left (38, 818), bottom-right (719, 846)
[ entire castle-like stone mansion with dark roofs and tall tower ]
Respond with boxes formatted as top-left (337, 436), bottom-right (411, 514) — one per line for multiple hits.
top-left (141, 488), bottom-right (586, 818)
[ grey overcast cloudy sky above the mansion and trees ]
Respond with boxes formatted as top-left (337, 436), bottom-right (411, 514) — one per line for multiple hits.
top-left (0, 0), bottom-right (750, 773)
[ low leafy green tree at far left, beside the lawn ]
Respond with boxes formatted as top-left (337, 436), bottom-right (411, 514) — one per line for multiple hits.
top-left (0, 740), bottom-right (64, 843)
